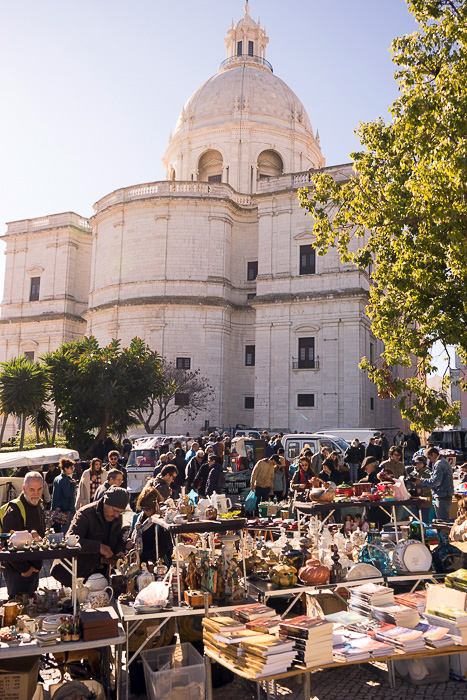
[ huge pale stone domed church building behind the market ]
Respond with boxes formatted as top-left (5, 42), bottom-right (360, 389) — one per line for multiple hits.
top-left (0, 3), bottom-right (397, 433)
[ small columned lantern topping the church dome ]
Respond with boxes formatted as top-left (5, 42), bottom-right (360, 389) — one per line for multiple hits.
top-left (220, 1), bottom-right (272, 73)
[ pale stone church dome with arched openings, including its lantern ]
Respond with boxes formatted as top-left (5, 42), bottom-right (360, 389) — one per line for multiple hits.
top-left (163, 2), bottom-right (325, 193)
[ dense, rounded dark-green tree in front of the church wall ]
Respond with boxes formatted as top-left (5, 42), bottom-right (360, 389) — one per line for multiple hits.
top-left (42, 337), bottom-right (161, 451)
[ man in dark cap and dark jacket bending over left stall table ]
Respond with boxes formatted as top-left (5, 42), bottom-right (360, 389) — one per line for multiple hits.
top-left (50, 486), bottom-right (129, 586)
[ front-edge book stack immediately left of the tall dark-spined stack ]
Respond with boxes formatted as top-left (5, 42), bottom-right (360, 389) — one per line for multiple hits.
top-left (237, 632), bottom-right (295, 678)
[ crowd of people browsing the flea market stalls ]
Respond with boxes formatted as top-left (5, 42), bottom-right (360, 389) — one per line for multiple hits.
top-left (2, 431), bottom-right (467, 597)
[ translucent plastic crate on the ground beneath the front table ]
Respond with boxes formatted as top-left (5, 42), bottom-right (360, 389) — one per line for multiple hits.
top-left (141, 642), bottom-right (205, 700)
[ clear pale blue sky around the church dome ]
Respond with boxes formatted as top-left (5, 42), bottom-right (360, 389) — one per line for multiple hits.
top-left (0, 0), bottom-right (415, 293)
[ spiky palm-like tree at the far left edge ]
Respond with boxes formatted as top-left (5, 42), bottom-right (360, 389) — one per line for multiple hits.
top-left (0, 356), bottom-right (48, 449)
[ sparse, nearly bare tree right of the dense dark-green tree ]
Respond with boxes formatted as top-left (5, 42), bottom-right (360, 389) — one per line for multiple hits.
top-left (134, 359), bottom-right (214, 433)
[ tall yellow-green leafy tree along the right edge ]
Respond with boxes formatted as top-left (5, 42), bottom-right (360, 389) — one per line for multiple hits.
top-left (299, 0), bottom-right (467, 430)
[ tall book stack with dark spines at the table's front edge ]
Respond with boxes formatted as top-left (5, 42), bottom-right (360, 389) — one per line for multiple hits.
top-left (279, 615), bottom-right (333, 668)
